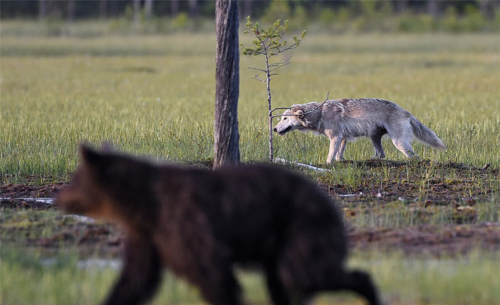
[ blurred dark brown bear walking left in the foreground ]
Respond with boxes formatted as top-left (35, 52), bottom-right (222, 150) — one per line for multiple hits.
top-left (57, 146), bottom-right (381, 305)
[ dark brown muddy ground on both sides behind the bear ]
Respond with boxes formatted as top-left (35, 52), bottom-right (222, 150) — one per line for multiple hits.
top-left (0, 161), bottom-right (500, 257)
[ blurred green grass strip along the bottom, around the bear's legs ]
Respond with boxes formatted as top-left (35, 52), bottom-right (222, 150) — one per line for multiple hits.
top-left (0, 247), bottom-right (500, 305)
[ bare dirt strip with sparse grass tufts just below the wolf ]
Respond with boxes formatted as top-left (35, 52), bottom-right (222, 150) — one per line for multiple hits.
top-left (320, 160), bottom-right (500, 205)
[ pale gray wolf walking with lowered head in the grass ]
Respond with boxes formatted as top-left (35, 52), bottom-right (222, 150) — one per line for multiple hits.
top-left (274, 98), bottom-right (446, 163)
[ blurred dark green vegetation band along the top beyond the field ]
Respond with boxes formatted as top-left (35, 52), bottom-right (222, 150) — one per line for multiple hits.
top-left (0, 0), bottom-right (500, 37)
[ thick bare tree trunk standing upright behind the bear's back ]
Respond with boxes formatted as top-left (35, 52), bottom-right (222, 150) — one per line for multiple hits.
top-left (214, 0), bottom-right (240, 168)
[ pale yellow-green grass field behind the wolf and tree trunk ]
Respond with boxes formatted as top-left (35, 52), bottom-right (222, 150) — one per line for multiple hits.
top-left (0, 30), bottom-right (500, 182)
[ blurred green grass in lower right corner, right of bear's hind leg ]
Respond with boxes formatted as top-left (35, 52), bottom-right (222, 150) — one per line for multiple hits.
top-left (350, 252), bottom-right (500, 305)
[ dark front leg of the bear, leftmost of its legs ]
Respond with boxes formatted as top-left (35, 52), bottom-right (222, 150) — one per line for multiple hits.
top-left (104, 236), bottom-right (162, 305)
